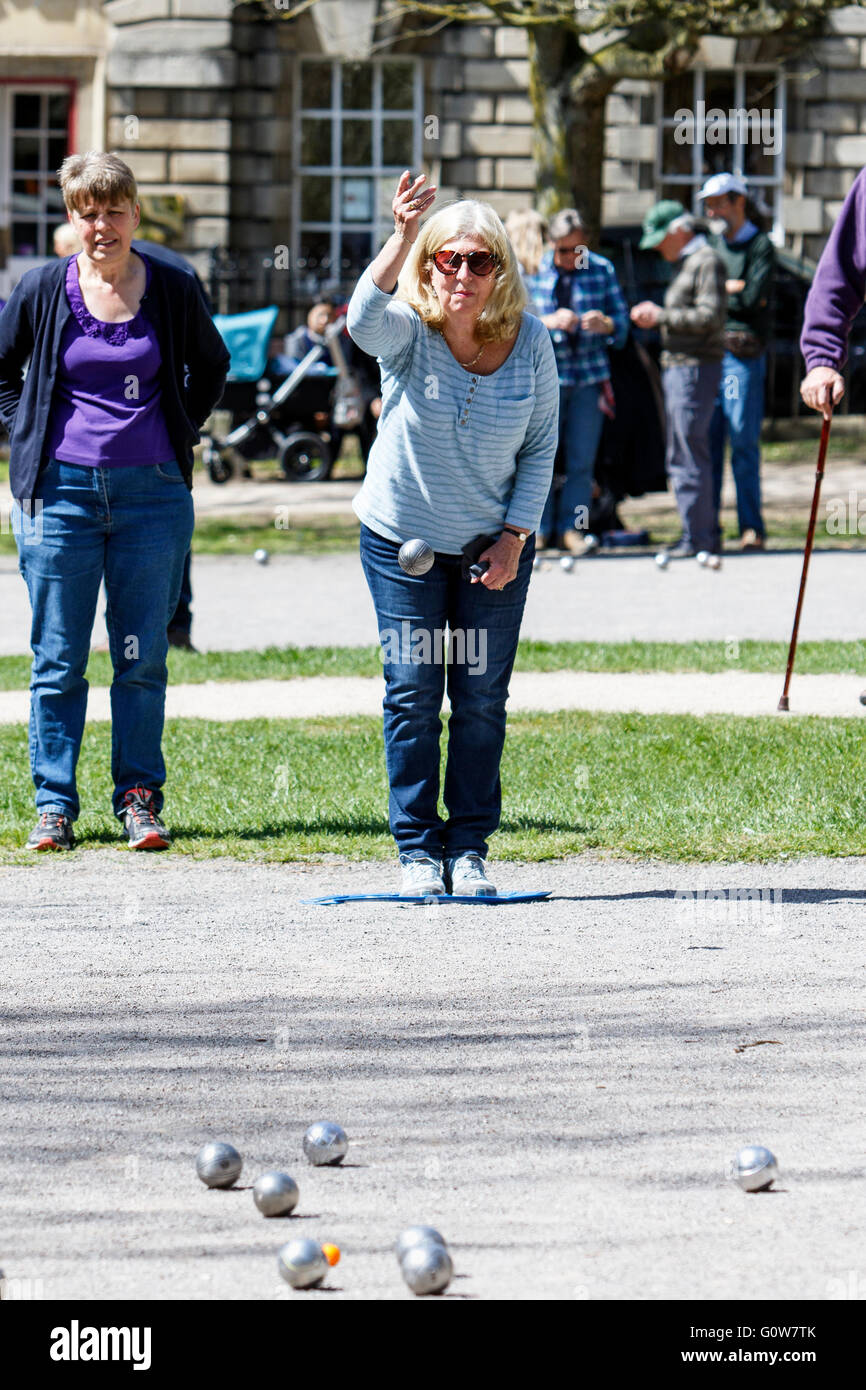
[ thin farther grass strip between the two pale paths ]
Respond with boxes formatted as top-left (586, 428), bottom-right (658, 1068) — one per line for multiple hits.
top-left (0, 641), bottom-right (866, 691)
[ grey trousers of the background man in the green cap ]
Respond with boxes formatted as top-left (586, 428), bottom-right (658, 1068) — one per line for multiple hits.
top-left (662, 361), bottom-right (721, 552)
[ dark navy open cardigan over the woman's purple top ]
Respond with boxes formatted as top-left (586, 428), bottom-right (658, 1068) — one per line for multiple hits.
top-left (0, 256), bottom-right (229, 502)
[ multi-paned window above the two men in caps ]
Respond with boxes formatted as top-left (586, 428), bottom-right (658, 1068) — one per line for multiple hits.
top-left (656, 68), bottom-right (785, 243)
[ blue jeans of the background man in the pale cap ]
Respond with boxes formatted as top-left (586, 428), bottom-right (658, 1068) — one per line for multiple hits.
top-left (710, 352), bottom-right (767, 535)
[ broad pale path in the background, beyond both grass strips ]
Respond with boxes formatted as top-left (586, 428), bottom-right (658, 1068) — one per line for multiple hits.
top-left (0, 550), bottom-right (866, 655)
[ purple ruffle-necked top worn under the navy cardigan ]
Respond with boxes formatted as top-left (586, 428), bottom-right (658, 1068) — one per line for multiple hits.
top-left (47, 256), bottom-right (175, 467)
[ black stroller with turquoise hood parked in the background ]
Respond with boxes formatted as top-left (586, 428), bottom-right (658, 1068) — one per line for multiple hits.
top-left (203, 304), bottom-right (363, 482)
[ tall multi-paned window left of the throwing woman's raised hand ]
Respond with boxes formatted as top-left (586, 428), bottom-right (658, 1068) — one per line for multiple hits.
top-left (292, 58), bottom-right (421, 293)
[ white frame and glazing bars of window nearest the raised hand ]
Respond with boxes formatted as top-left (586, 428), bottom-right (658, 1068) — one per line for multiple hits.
top-left (291, 54), bottom-right (424, 292)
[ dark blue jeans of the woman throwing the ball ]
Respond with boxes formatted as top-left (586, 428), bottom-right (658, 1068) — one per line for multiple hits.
top-left (361, 525), bottom-right (535, 859)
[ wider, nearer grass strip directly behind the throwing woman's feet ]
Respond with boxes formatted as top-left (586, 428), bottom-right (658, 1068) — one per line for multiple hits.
top-left (0, 712), bottom-right (866, 863)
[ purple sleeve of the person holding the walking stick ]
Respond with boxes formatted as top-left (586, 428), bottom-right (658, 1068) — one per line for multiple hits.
top-left (799, 168), bottom-right (866, 371)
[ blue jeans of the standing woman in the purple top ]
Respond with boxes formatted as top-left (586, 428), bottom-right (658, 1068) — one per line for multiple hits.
top-left (14, 459), bottom-right (193, 820)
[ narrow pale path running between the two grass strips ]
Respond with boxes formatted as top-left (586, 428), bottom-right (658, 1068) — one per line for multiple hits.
top-left (0, 671), bottom-right (866, 724)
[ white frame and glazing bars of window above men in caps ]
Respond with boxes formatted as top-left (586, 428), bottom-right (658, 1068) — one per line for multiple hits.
top-left (656, 63), bottom-right (787, 246)
